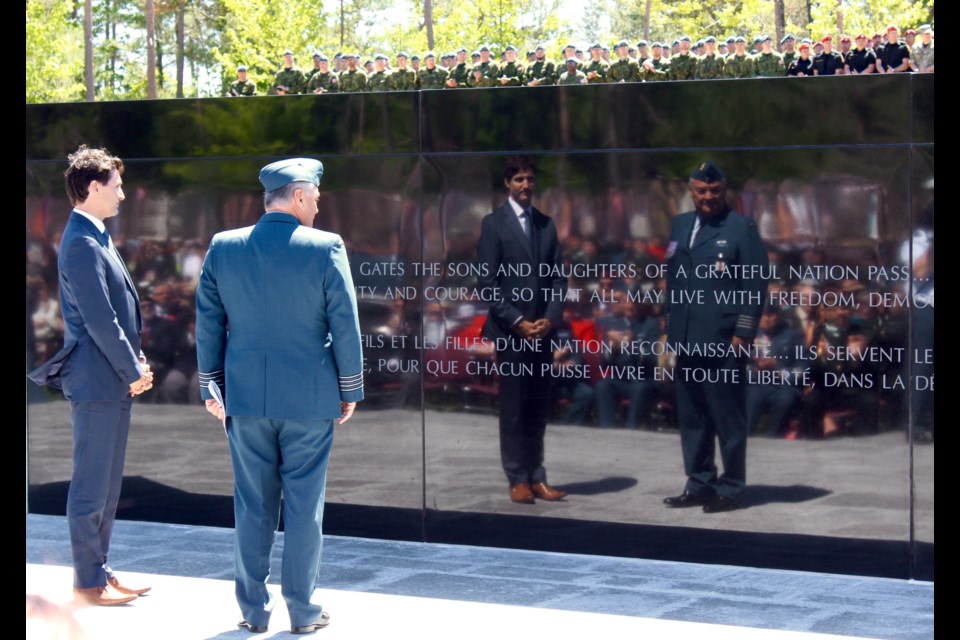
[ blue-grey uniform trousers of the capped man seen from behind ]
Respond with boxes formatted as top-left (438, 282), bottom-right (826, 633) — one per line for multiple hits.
top-left (227, 417), bottom-right (333, 627)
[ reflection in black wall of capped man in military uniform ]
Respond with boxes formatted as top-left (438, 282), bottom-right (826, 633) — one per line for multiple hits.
top-left (663, 162), bottom-right (769, 513)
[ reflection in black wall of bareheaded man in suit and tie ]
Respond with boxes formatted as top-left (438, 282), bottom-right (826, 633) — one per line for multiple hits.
top-left (477, 157), bottom-right (567, 504)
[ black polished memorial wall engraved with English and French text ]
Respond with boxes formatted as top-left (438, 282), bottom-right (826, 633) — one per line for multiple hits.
top-left (26, 76), bottom-right (934, 579)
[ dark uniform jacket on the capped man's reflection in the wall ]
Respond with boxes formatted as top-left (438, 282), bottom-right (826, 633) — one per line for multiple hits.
top-left (666, 209), bottom-right (769, 344)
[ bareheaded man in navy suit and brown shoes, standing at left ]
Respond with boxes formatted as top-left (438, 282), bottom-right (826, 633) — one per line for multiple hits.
top-left (30, 146), bottom-right (153, 605)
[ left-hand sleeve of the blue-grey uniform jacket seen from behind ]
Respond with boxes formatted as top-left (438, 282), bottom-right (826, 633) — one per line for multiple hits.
top-left (196, 238), bottom-right (227, 400)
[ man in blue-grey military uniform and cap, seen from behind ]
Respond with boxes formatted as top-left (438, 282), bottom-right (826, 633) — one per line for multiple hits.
top-left (197, 158), bottom-right (363, 633)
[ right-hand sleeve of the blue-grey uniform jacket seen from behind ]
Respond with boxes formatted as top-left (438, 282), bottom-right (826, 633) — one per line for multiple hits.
top-left (323, 238), bottom-right (363, 402)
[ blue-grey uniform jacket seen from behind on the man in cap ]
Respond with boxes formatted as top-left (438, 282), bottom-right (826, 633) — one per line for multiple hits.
top-left (197, 211), bottom-right (363, 420)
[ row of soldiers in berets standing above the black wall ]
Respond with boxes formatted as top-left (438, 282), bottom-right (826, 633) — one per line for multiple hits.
top-left (229, 27), bottom-right (928, 96)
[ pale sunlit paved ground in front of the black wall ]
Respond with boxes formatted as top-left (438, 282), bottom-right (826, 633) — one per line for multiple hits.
top-left (26, 515), bottom-right (934, 640)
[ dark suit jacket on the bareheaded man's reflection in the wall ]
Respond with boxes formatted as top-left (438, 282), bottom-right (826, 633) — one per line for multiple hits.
top-left (477, 202), bottom-right (567, 339)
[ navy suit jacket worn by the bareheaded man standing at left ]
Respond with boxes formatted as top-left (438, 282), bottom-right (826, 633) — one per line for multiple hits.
top-left (28, 212), bottom-right (144, 402)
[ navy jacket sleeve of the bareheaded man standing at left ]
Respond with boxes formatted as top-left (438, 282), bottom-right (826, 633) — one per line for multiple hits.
top-left (65, 236), bottom-right (145, 385)
